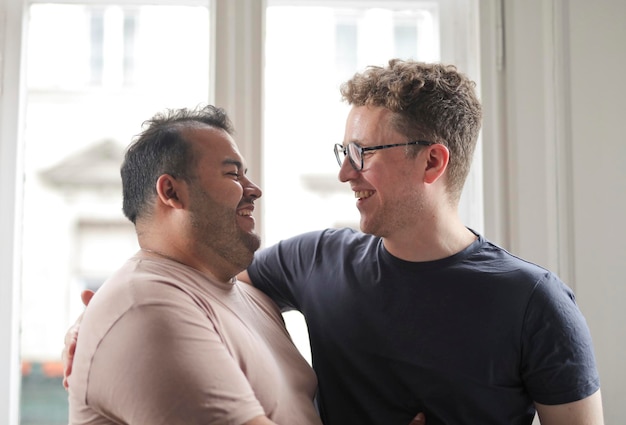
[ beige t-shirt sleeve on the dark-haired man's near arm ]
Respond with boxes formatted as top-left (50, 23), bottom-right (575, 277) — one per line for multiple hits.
top-left (86, 288), bottom-right (264, 425)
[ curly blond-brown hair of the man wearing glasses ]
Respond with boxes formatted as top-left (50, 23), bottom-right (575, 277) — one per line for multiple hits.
top-left (340, 59), bottom-right (482, 202)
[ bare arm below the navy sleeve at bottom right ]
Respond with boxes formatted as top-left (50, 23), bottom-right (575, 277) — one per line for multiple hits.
top-left (535, 390), bottom-right (604, 425)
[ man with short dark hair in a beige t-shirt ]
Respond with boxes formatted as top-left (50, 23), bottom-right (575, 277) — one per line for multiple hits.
top-left (69, 106), bottom-right (322, 425)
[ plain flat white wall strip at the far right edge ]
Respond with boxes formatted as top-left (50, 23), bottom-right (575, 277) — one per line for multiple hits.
top-left (568, 0), bottom-right (626, 424)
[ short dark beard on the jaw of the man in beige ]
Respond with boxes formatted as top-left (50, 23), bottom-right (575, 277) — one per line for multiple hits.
top-left (189, 184), bottom-right (261, 271)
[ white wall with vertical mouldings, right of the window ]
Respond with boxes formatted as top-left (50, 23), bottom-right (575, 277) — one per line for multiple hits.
top-left (481, 0), bottom-right (626, 424)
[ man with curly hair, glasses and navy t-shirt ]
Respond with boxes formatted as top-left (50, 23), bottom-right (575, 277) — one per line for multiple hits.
top-left (241, 60), bottom-right (603, 425)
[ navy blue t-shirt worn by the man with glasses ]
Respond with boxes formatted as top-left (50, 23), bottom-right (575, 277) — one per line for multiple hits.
top-left (248, 229), bottom-right (599, 425)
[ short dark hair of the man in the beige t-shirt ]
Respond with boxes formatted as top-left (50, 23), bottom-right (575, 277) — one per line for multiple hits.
top-left (120, 105), bottom-right (234, 224)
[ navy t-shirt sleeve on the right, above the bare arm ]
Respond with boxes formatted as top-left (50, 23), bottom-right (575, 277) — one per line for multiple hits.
top-left (522, 273), bottom-right (600, 405)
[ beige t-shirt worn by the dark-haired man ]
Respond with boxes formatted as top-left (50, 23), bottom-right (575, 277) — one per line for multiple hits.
top-left (69, 253), bottom-right (321, 425)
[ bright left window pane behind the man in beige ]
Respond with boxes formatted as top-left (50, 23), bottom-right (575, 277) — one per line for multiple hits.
top-left (21, 4), bottom-right (210, 425)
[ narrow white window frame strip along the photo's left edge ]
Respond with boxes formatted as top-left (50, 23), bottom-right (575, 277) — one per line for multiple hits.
top-left (0, 0), bottom-right (26, 425)
